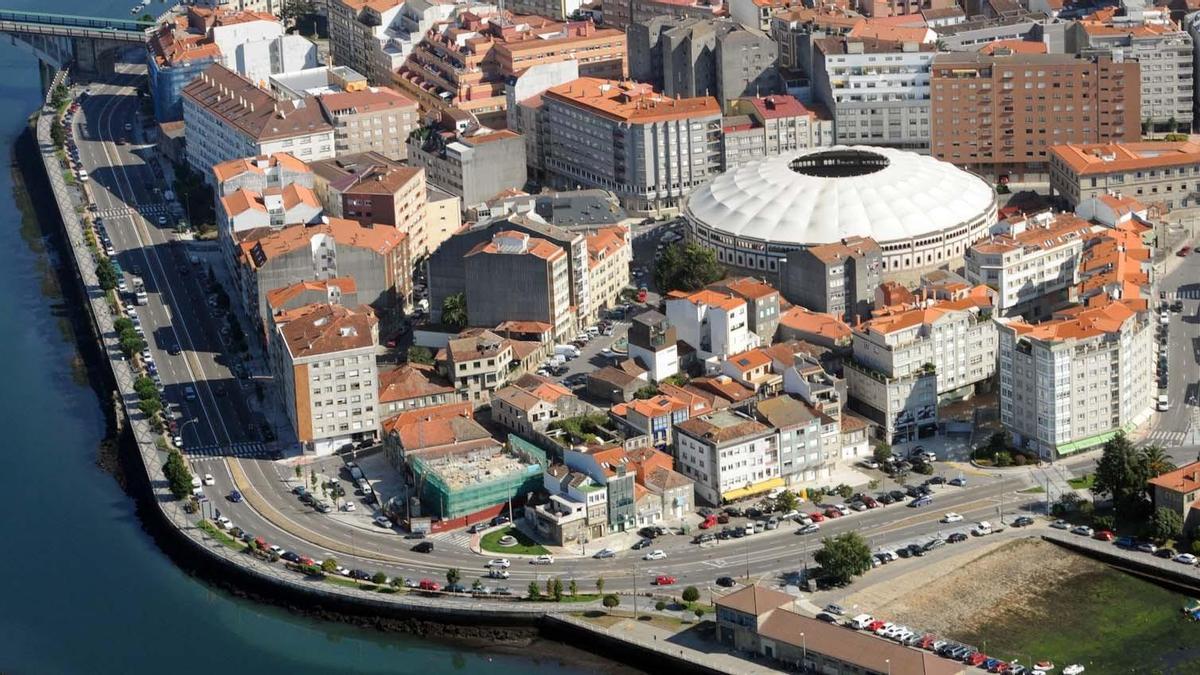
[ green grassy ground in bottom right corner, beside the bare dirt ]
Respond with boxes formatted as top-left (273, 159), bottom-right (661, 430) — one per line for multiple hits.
top-left (953, 569), bottom-right (1200, 674)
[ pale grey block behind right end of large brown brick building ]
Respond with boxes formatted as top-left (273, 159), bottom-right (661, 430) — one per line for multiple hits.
top-left (1068, 6), bottom-right (1195, 133)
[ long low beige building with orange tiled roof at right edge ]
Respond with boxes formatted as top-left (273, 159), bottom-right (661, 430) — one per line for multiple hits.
top-left (1050, 142), bottom-right (1200, 209)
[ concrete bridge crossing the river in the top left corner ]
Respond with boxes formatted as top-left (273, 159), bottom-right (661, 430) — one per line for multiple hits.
top-left (0, 10), bottom-right (156, 85)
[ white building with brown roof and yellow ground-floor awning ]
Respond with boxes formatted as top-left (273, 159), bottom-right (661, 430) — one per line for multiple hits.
top-left (674, 410), bottom-right (785, 506)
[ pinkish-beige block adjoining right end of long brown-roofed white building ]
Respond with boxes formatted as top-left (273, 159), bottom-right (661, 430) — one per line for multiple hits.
top-left (317, 86), bottom-right (419, 160)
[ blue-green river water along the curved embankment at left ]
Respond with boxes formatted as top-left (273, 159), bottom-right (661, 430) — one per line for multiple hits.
top-left (0, 6), bottom-right (609, 675)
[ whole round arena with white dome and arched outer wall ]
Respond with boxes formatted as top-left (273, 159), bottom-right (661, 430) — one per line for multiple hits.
top-left (683, 145), bottom-right (996, 279)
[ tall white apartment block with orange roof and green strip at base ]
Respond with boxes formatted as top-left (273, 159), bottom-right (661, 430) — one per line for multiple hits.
top-left (1000, 299), bottom-right (1156, 459)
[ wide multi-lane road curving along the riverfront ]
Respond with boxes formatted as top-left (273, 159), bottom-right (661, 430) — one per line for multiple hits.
top-left (74, 64), bottom-right (1200, 592)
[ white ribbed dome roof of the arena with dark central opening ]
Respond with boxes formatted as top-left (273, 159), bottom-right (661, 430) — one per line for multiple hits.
top-left (686, 145), bottom-right (995, 244)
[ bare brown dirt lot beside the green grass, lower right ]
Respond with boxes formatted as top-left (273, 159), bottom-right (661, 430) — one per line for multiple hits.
top-left (842, 538), bottom-right (1104, 634)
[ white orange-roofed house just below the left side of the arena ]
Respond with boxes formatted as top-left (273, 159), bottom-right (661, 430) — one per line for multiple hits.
top-left (666, 289), bottom-right (760, 371)
